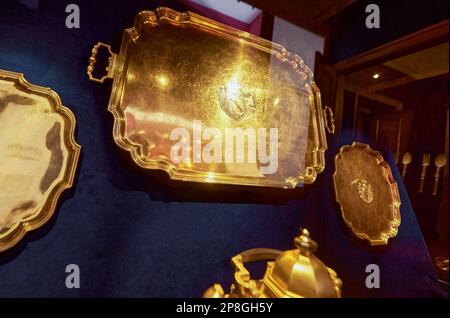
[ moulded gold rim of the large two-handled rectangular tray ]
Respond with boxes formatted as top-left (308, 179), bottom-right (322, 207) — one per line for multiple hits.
top-left (93, 7), bottom-right (328, 188)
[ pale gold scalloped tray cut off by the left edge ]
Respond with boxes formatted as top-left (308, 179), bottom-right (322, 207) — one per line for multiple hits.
top-left (0, 70), bottom-right (80, 251)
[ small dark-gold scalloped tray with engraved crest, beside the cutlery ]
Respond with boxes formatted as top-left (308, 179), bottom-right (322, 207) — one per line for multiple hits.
top-left (333, 142), bottom-right (401, 245)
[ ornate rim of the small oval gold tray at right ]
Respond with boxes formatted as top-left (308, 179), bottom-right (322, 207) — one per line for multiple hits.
top-left (333, 141), bottom-right (401, 245)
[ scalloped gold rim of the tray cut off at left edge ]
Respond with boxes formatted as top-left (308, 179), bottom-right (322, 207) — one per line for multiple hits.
top-left (0, 70), bottom-right (81, 252)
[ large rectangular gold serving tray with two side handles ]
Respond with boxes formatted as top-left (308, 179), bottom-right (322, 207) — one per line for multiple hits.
top-left (87, 8), bottom-right (332, 188)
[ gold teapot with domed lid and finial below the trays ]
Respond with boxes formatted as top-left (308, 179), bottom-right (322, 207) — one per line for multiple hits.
top-left (203, 229), bottom-right (342, 298)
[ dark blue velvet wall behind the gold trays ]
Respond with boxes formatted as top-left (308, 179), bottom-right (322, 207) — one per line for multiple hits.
top-left (0, 0), bottom-right (446, 297)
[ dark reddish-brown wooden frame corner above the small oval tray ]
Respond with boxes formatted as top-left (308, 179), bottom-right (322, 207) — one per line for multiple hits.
top-left (332, 19), bottom-right (449, 139)
